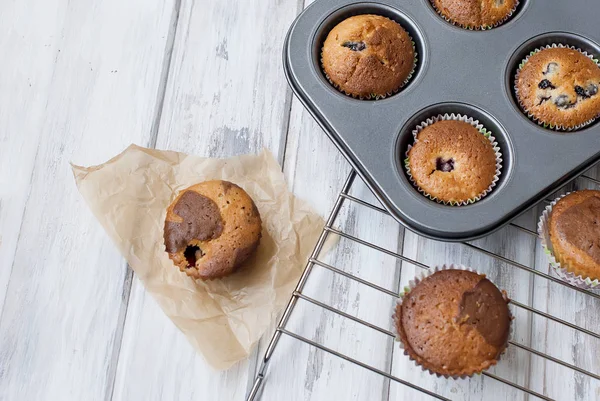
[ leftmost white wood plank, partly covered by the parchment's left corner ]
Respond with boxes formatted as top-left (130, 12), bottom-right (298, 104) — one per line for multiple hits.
top-left (0, 0), bottom-right (173, 400)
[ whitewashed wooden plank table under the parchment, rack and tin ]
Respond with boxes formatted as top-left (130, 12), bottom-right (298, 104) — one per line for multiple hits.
top-left (0, 0), bottom-right (600, 401)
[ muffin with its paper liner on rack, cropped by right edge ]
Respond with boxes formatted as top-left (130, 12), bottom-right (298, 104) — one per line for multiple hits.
top-left (538, 190), bottom-right (600, 288)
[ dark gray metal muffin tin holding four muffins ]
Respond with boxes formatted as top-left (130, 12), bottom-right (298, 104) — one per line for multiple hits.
top-left (283, 0), bottom-right (600, 241)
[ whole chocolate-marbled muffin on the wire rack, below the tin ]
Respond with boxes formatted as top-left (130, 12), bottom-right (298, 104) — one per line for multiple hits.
top-left (396, 269), bottom-right (511, 376)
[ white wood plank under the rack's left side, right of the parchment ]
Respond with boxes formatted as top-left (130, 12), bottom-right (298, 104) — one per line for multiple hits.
top-left (260, 95), bottom-right (402, 400)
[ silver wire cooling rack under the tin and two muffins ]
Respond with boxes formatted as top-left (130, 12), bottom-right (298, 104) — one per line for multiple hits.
top-left (247, 171), bottom-right (600, 401)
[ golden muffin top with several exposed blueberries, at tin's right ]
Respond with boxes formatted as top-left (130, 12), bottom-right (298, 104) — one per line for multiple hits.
top-left (516, 47), bottom-right (600, 129)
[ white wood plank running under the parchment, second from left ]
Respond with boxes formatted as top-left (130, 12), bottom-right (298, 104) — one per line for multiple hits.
top-left (109, 0), bottom-right (298, 401)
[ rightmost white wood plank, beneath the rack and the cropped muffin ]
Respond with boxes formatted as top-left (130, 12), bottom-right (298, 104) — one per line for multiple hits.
top-left (531, 167), bottom-right (600, 401)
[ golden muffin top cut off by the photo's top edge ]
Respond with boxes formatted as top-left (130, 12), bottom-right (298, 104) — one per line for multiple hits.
top-left (433, 0), bottom-right (518, 28)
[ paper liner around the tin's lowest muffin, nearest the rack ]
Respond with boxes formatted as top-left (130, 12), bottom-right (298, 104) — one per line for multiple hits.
top-left (404, 113), bottom-right (503, 206)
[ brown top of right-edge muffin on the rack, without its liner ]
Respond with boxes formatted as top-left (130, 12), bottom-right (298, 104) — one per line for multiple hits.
top-left (550, 190), bottom-right (600, 280)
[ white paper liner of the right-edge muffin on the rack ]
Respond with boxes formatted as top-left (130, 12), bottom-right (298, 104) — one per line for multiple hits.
top-left (538, 192), bottom-right (600, 290)
